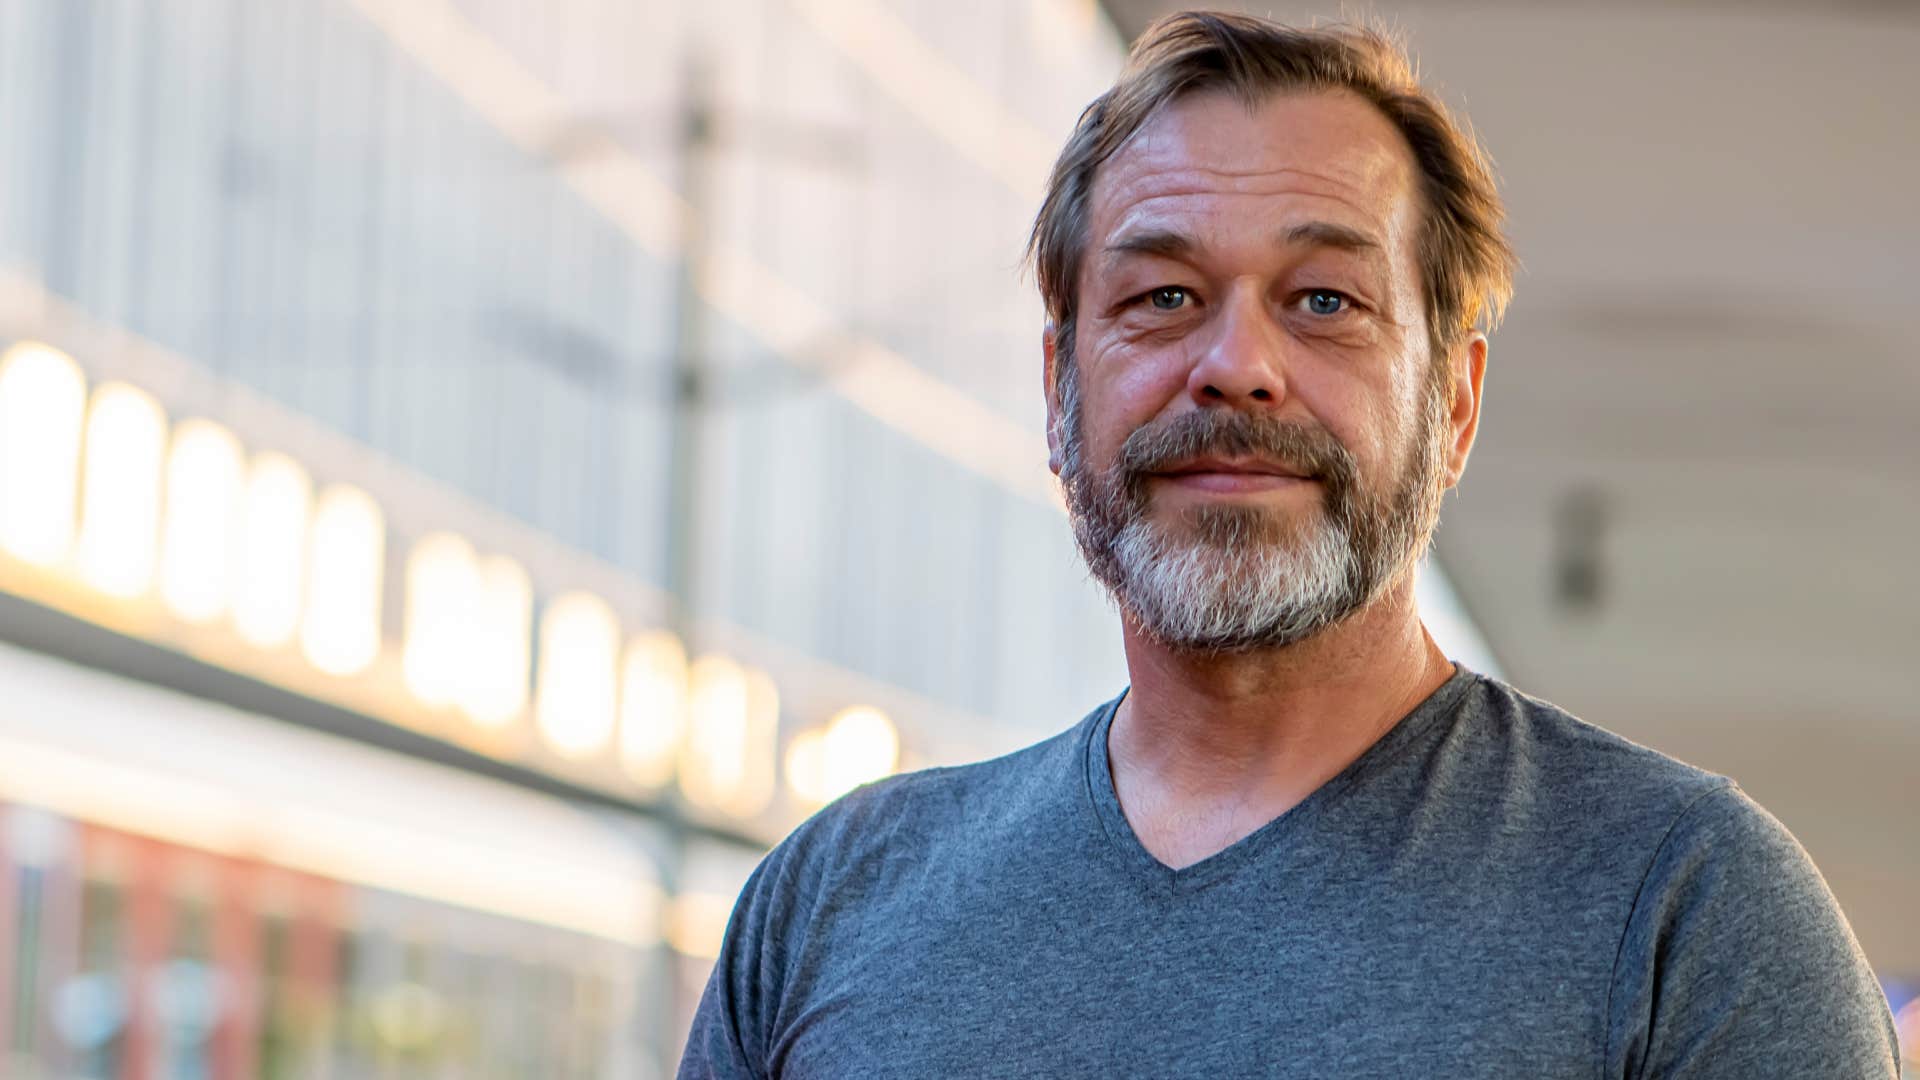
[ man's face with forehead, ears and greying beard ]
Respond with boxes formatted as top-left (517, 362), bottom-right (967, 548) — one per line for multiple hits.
top-left (1048, 92), bottom-right (1476, 651)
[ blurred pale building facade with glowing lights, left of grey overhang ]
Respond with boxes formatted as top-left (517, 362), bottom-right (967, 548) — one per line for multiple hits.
top-left (0, 0), bottom-right (1492, 1076)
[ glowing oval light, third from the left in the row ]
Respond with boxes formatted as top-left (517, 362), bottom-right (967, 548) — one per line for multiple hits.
top-left (159, 419), bottom-right (244, 623)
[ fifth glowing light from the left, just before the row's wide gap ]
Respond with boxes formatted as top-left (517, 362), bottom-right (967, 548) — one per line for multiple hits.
top-left (300, 484), bottom-right (386, 676)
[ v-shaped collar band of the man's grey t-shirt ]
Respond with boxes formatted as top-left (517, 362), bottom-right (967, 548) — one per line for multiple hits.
top-left (1081, 665), bottom-right (1476, 896)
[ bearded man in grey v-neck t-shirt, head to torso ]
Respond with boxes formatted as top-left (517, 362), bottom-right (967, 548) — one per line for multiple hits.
top-left (682, 15), bottom-right (1895, 1080)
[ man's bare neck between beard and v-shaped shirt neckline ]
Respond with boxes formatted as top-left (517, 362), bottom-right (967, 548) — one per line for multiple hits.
top-left (1108, 573), bottom-right (1453, 867)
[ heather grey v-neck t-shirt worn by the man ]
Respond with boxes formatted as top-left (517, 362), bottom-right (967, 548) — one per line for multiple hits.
top-left (680, 671), bottom-right (1897, 1080)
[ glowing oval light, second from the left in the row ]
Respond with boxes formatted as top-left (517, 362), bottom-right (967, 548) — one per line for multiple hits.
top-left (77, 382), bottom-right (167, 600)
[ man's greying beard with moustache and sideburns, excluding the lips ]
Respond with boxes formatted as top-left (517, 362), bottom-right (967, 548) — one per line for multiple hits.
top-left (1058, 361), bottom-right (1446, 653)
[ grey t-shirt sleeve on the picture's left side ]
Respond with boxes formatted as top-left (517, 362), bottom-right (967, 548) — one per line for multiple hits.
top-left (678, 840), bottom-right (791, 1080)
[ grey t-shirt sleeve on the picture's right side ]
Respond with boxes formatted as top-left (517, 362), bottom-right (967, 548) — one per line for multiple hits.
top-left (1605, 782), bottom-right (1899, 1080)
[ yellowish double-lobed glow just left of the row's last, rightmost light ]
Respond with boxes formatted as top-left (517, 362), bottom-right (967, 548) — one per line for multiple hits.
top-left (680, 655), bottom-right (780, 817)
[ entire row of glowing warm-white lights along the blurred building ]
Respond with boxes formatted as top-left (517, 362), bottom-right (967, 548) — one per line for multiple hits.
top-left (0, 342), bottom-right (900, 819)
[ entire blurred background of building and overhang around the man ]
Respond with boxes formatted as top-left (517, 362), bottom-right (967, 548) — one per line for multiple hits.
top-left (0, 0), bottom-right (1920, 1080)
